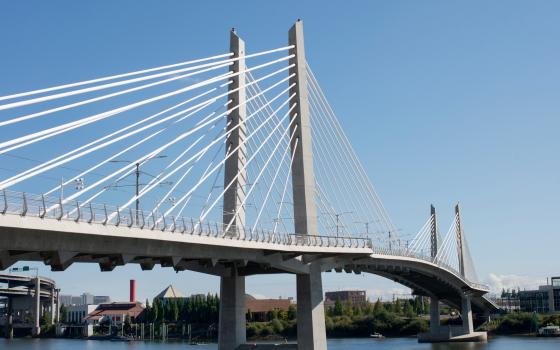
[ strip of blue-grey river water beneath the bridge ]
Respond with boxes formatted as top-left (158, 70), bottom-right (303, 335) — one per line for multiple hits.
top-left (0, 337), bottom-right (560, 350)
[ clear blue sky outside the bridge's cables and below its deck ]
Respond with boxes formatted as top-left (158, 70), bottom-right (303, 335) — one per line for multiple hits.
top-left (0, 0), bottom-right (560, 298)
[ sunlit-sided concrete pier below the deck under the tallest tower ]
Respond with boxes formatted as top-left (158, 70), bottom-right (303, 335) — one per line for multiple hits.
top-left (296, 264), bottom-right (327, 350)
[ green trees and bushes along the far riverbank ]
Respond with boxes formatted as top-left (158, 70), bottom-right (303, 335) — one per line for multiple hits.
top-left (8, 294), bottom-right (560, 343)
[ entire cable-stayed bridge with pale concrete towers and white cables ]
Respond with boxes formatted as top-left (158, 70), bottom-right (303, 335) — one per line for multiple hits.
top-left (0, 21), bottom-right (494, 350)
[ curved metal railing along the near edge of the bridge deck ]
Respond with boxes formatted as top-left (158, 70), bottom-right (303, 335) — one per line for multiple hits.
top-left (0, 190), bottom-right (372, 248)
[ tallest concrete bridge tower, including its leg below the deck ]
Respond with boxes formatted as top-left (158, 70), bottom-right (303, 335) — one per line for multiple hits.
top-left (288, 20), bottom-right (327, 350)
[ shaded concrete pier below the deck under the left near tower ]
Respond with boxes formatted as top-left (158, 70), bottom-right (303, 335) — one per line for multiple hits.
top-left (218, 268), bottom-right (247, 350)
